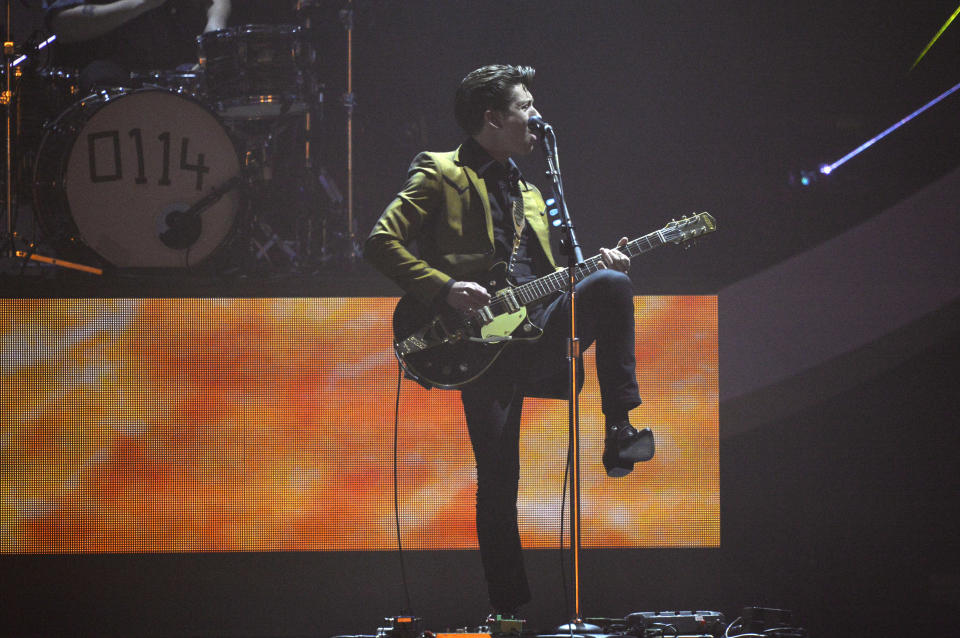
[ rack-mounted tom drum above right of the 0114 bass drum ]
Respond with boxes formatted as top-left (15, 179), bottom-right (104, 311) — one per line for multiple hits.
top-left (197, 24), bottom-right (307, 120)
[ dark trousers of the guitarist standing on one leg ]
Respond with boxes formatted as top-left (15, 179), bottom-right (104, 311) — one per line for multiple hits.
top-left (461, 270), bottom-right (640, 612)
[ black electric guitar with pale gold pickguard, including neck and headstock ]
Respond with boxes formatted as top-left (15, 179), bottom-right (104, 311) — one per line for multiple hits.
top-left (393, 213), bottom-right (717, 389)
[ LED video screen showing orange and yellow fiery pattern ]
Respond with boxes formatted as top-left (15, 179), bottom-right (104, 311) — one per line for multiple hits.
top-left (0, 296), bottom-right (720, 554)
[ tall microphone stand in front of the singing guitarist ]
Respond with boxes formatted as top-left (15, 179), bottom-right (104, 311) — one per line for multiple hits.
top-left (539, 124), bottom-right (599, 634)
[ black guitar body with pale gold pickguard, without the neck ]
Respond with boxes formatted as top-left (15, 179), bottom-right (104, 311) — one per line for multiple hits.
top-left (393, 263), bottom-right (543, 389)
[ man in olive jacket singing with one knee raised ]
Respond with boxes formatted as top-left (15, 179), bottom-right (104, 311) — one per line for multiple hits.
top-left (364, 65), bottom-right (654, 616)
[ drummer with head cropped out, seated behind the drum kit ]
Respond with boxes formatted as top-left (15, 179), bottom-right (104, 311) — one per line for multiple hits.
top-left (43, 0), bottom-right (230, 94)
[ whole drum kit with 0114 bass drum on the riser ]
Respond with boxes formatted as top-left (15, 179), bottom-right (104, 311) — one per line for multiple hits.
top-left (7, 0), bottom-right (358, 274)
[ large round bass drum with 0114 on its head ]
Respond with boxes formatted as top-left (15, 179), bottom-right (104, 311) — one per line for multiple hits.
top-left (34, 89), bottom-right (240, 268)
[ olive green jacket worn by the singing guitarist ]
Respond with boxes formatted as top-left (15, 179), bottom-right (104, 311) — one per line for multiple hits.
top-left (364, 148), bottom-right (556, 303)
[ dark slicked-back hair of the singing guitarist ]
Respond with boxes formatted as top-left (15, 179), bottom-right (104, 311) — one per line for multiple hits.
top-left (453, 64), bottom-right (536, 135)
